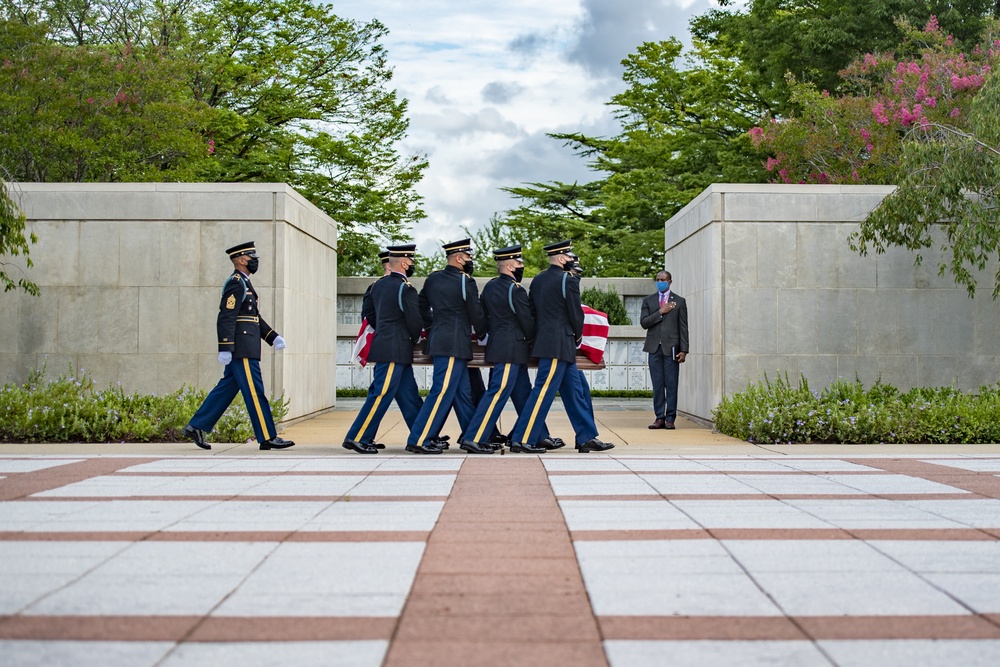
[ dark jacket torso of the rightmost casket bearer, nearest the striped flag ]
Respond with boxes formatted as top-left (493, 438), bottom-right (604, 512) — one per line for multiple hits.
top-left (528, 264), bottom-right (583, 363)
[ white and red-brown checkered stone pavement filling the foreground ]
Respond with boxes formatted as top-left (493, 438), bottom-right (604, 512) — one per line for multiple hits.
top-left (0, 450), bottom-right (1000, 667)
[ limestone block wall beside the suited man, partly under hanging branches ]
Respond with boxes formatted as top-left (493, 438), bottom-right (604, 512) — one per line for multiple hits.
top-left (665, 184), bottom-right (1000, 418)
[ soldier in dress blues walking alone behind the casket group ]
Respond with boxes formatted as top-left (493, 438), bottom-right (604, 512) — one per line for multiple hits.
top-left (184, 241), bottom-right (295, 449)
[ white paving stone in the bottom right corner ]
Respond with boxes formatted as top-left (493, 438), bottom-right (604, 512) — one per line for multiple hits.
top-left (819, 639), bottom-right (1000, 667)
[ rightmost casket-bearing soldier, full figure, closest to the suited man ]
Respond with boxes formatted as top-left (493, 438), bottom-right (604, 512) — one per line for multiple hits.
top-left (511, 241), bottom-right (614, 453)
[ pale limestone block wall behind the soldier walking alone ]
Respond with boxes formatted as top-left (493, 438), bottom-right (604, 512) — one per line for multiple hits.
top-left (0, 183), bottom-right (337, 417)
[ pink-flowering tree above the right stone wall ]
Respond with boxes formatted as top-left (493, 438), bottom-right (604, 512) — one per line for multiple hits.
top-left (749, 17), bottom-right (1000, 183)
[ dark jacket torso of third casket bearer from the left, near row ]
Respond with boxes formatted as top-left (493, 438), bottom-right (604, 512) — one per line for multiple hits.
top-left (481, 274), bottom-right (535, 364)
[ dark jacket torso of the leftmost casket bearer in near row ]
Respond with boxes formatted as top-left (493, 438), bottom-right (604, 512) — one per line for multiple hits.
top-left (368, 273), bottom-right (421, 364)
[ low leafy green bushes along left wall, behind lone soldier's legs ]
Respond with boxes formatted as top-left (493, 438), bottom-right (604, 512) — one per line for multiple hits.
top-left (0, 366), bottom-right (288, 442)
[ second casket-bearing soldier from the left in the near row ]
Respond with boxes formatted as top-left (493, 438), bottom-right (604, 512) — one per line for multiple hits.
top-left (406, 239), bottom-right (493, 454)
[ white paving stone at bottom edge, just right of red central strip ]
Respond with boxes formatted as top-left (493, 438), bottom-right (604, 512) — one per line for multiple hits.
top-left (604, 640), bottom-right (834, 667)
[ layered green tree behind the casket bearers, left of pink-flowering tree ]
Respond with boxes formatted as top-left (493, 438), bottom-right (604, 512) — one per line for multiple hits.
top-left (505, 39), bottom-right (766, 276)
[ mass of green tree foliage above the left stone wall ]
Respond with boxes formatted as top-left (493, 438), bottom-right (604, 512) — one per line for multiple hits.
top-left (0, 0), bottom-right (427, 274)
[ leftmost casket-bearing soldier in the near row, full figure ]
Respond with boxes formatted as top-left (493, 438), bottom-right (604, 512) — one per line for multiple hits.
top-left (344, 243), bottom-right (421, 454)
